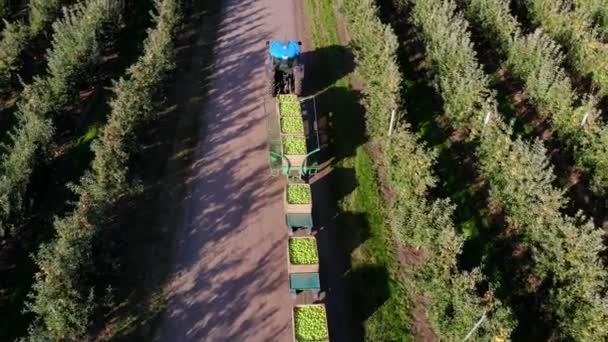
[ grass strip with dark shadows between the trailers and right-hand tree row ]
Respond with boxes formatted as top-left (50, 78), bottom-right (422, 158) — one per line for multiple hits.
top-left (306, 0), bottom-right (412, 341)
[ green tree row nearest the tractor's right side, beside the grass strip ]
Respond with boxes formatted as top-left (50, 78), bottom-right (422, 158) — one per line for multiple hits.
top-left (342, 0), bottom-right (514, 340)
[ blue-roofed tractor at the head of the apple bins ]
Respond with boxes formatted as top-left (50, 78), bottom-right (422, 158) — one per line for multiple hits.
top-left (265, 40), bottom-right (304, 97)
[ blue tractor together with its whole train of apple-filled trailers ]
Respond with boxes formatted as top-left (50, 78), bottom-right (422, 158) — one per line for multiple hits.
top-left (264, 40), bottom-right (329, 342)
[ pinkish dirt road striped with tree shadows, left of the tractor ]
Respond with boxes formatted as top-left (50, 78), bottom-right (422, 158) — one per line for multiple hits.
top-left (157, 0), bottom-right (303, 341)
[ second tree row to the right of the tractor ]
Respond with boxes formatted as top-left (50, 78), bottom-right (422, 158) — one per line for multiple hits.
top-left (402, 0), bottom-right (608, 341)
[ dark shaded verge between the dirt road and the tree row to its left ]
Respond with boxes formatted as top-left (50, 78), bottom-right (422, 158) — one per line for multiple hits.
top-left (95, 3), bottom-right (228, 341)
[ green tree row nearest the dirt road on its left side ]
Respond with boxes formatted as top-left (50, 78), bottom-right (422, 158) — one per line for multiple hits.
top-left (28, 0), bottom-right (179, 341)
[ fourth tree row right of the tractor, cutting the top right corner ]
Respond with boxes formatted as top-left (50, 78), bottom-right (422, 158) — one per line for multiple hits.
top-left (519, 0), bottom-right (608, 95)
